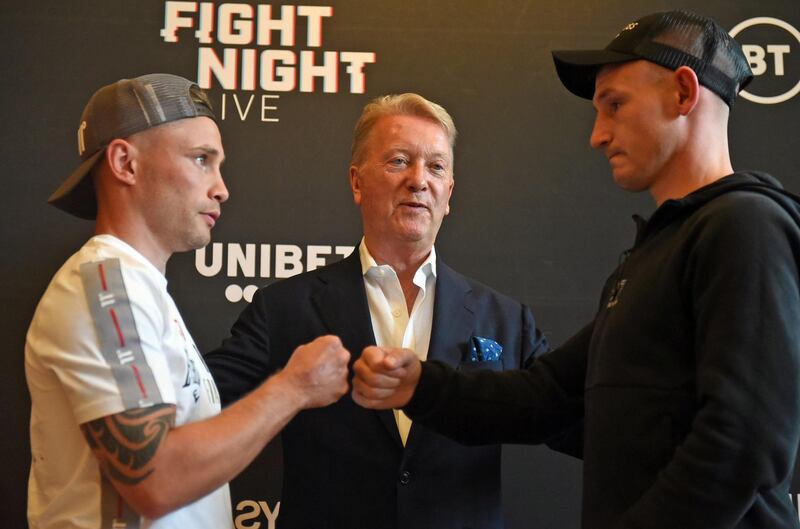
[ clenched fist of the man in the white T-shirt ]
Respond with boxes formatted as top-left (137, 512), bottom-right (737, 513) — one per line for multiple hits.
top-left (276, 336), bottom-right (350, 408)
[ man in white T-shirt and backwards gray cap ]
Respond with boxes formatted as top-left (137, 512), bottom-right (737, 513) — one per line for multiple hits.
top-left (25, 74), bottom-right (349, 529)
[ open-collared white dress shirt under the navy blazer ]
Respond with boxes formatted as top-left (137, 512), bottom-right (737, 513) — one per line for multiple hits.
top-left (358, 238), bottom-right (436, 445)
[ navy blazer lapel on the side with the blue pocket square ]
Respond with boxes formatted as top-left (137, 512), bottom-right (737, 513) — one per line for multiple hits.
top-left (406, 259), bottom-right (475, 449)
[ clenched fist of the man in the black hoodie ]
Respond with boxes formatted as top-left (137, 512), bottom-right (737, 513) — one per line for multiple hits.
top-left (353, 346), bottom-right (422, 410)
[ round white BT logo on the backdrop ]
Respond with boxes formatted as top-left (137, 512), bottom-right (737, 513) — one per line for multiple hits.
top-left (730, 17), bottom-right (800, 105)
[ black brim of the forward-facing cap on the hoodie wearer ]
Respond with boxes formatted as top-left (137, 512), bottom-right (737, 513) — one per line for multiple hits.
top-left (552, 50), bottom-right (640, 99)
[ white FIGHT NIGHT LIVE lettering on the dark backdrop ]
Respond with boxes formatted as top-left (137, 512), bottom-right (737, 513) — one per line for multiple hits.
top-left (160, 1), bottom-right (377, 123)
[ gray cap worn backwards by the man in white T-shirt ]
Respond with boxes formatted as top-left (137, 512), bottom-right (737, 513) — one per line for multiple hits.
top-left (47, 73), bottom-right (217, 219)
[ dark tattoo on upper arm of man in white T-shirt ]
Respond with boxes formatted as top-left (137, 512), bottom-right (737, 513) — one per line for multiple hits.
top-left (81, 404), bottom-right (175, 485)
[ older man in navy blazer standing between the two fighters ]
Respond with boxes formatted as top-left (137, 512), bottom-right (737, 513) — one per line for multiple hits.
top-left (206, 94), bottom-right (547, 529)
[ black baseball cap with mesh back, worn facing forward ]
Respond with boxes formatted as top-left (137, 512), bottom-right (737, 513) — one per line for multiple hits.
top-left (553, 11), bottom-right (753, 107)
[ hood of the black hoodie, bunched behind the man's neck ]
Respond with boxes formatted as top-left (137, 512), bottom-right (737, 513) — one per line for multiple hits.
top-left (634, 171), bottom-right (800, 245)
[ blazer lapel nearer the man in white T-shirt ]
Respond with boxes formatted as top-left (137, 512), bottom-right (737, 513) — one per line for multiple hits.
top-left (311, 246), bottom-right (403, 446)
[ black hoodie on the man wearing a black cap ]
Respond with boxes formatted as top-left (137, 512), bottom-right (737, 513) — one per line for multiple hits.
top-left (406, 173), bottom-right (800, 529)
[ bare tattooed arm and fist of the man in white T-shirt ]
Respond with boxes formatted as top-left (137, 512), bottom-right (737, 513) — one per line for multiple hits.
top-left (82, 336), bottom-right (350, 518)
